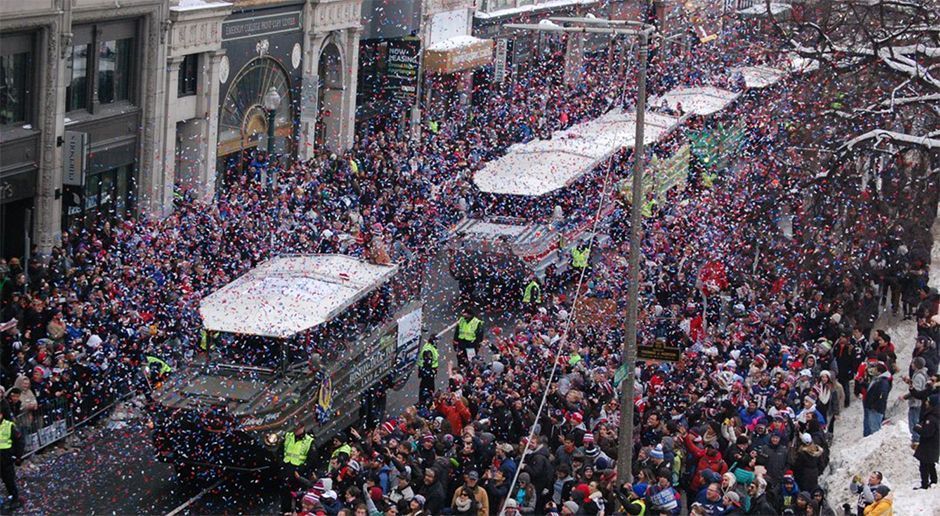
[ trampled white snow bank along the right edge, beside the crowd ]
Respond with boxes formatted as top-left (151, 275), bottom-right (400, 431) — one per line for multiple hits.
top-left (821, 211), bottom-right (940, 516)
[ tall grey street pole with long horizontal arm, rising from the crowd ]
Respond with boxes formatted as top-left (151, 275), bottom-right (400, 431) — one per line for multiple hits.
top-left (503, 17), bottom-right (656, 492)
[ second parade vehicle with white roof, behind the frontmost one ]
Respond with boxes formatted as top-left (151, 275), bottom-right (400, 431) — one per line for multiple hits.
top-left (450, 109), bottom-right (681, 298)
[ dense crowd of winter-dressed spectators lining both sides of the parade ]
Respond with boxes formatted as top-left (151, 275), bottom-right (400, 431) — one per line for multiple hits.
top-left (0, 10), bottom-right (940, 516)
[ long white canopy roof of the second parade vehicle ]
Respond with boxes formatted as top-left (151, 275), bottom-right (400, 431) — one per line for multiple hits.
top-left (473, 110), bottom-right (680, 197)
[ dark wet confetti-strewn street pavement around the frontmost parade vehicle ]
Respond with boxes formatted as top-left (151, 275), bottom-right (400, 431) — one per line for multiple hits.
top-left (12, 249), bottom-right (528, 514)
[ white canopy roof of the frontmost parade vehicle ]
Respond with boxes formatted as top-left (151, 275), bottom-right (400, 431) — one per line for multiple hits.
top-left (199, 254), bottom-right (398, 338)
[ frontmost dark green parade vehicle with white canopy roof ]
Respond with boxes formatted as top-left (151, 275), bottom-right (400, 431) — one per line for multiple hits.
top-left (153, 254), bottom-right (423, 471)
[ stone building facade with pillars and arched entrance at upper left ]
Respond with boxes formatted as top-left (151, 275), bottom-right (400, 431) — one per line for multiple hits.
top-left (0, 0), bottom-right (361, 257)
